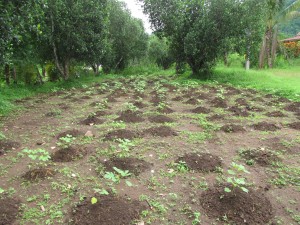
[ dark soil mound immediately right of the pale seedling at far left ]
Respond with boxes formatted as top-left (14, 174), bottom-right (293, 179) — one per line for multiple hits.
top-left (51, 146), bottom-right (87, 162)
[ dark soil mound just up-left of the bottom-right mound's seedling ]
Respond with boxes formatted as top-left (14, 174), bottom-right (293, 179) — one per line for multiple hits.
top-left (176, 153), bottom-right (222, 172)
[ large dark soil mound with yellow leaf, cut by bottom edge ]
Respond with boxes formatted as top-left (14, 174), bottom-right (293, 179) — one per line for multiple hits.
top-left (69, 196), bottom-right (147, 225)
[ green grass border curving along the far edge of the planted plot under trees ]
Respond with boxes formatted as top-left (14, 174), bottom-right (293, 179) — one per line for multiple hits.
top-left (0, 66), bottom-right (300, 116)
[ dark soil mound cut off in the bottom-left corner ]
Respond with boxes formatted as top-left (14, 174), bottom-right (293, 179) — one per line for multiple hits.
top-left (0, 198), bottom-right (21, 225)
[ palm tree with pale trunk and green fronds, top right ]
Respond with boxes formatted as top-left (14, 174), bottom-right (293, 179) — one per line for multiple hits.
top-left (259, 0), bottom-right (300, 68)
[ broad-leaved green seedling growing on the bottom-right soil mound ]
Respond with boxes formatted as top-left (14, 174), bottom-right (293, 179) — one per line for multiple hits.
top-left (224, 162), bottom-right (249, 193)
